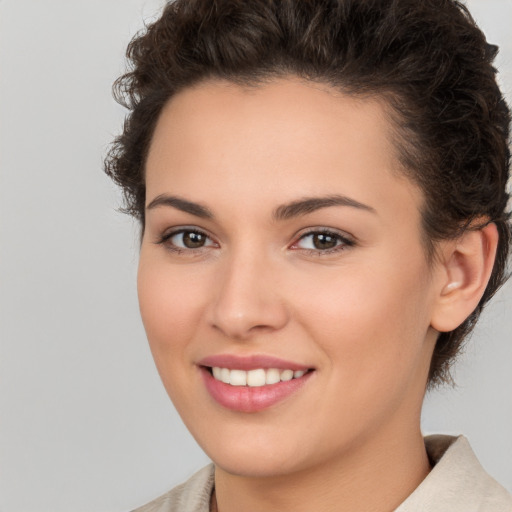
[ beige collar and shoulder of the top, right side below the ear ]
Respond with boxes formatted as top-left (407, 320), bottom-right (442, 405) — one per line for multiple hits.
top-left (396, 435), bottom-right (512, 512)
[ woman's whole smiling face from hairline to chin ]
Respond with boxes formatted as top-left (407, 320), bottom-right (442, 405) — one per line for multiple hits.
top-left (138, 77), bottom-right (435, 476)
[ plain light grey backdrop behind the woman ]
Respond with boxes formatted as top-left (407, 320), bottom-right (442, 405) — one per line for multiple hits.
top-left (0, 0), bottom-right (512, 512)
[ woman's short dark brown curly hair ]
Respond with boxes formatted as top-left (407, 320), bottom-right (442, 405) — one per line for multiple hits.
top-left (105, 0), bottom-right (512, 386)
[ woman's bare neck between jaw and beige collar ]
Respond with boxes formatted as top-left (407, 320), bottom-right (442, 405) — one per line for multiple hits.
top-left (212, 428), bottom-right (430, 512)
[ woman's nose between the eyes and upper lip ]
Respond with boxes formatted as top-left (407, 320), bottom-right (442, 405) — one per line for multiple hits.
top-left (210, 248), bottom-right (289, 340)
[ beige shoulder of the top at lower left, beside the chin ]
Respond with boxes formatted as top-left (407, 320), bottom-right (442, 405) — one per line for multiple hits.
top-left (132, 464), bottom-right (214, 512)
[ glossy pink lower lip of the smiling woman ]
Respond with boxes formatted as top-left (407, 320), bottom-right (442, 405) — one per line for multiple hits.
top-left (201, 367), bottom-right (313, 412)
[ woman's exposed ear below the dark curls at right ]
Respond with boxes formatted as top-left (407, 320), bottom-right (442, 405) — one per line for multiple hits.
top-left (430, 223), bottom-right (498, 332)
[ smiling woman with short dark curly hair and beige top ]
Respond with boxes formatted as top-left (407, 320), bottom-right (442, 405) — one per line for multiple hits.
top-left (106, 0), bottom-right (512, 512)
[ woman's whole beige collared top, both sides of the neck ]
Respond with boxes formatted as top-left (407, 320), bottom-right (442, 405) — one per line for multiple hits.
top-left (133, 435), bottom-right (512, 512)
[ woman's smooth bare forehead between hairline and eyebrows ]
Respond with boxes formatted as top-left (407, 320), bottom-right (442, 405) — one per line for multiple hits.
top-left (146, 78), bottom-right (421, 221)
